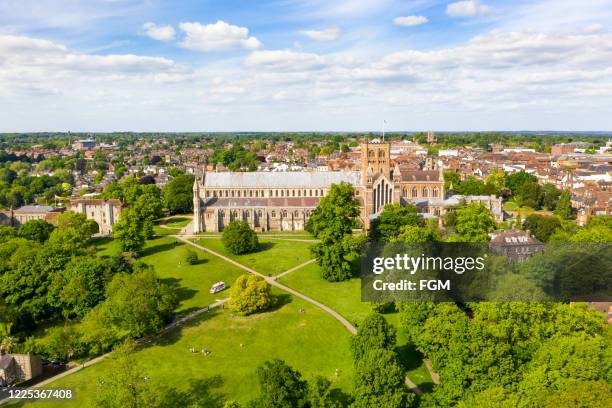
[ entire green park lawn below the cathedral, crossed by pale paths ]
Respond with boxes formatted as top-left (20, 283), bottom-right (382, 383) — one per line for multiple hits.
top-left (9, 228), bottom-right (431, 407)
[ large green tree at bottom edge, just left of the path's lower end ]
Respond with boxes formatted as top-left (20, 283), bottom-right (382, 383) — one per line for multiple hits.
top-left (352, 348), bottom-right (414, 408)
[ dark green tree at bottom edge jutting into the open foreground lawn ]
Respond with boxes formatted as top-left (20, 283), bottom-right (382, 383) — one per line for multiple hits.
top-left (253, 359), bottom-right (308, 408)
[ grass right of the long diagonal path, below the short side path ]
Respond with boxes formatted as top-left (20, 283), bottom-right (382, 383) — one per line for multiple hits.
top-left (278, 264), bottom-right (433, 392)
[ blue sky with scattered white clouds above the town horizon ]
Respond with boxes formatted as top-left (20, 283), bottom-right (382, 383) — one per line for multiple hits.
top-left (0, 0), bottom-right (612, 132)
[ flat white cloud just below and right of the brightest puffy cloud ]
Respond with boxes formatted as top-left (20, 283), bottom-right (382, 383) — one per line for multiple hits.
top-left (245, 50), bottom-right (326, 72)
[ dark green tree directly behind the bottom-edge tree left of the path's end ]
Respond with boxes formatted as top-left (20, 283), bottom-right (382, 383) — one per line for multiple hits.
top-left (351, 313), bottom-right (396, 361)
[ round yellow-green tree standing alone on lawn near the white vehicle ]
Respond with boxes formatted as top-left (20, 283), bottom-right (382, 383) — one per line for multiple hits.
top-left (228, 274), bottom-right (274, 315)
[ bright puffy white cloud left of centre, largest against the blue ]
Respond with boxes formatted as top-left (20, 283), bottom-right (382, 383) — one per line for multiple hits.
top-left (179, 20), bottom-right (261, 51)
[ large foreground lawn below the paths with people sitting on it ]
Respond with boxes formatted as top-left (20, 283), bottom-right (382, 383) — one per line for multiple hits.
top-left (16, 292), bottom-right (352, 407)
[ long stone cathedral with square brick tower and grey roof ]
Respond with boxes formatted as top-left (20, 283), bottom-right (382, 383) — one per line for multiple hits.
top-left (193, 142), bottom-right (445, 233)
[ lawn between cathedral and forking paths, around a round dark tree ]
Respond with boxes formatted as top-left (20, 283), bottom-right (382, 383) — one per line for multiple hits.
top-left (197, 236), bottom-right (312, 276)
